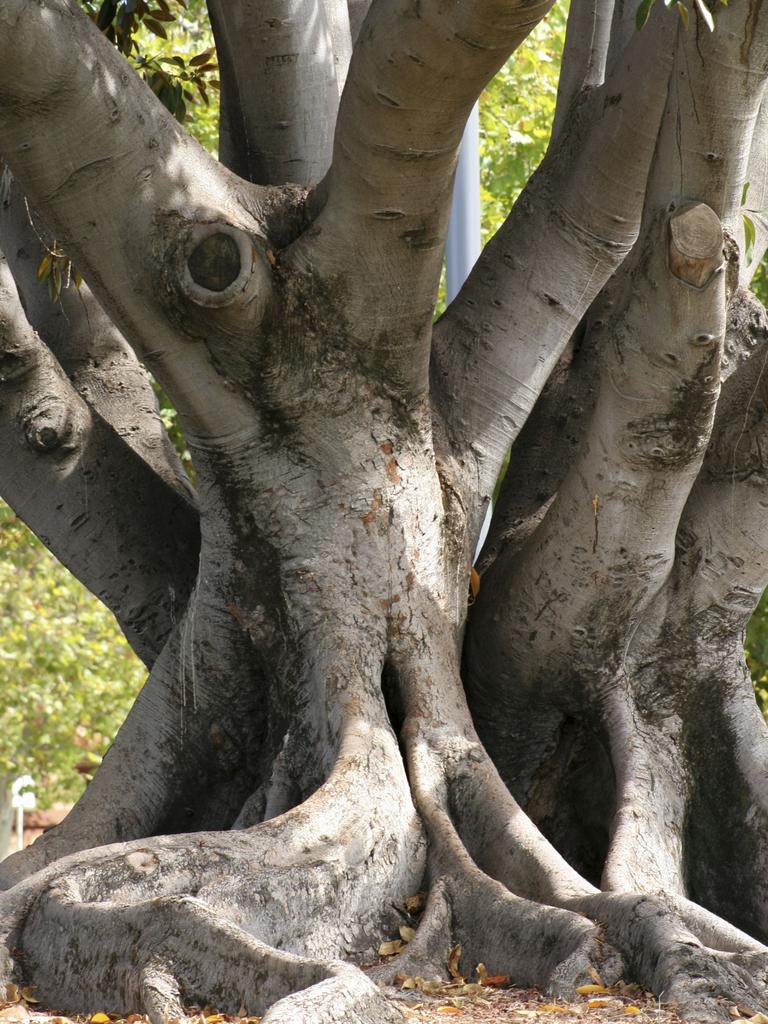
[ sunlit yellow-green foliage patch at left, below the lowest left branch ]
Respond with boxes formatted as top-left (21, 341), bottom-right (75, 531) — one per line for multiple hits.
top-left (0, 502), bottom-right (145, 806)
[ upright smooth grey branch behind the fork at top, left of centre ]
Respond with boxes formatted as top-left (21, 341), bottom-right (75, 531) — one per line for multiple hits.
top-left (208, 0), bottom-right (351, 185)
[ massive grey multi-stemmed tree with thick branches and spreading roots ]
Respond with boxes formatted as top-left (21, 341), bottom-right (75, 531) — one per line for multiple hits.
top-left (0, 0), bottom-right (768, 1024)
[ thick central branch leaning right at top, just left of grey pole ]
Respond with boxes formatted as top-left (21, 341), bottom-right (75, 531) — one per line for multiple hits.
top-left (288, 0), bottom-right (551, 393)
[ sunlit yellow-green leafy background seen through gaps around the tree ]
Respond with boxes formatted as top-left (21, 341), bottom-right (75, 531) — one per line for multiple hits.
top-left (0, 0), bottom-right (768, 806)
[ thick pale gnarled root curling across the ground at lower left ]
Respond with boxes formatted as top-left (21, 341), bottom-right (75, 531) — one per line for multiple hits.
top-left (0, 720), bottom-right (424, 1024)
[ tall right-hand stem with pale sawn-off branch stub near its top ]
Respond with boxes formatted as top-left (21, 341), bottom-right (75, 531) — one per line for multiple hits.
top-left (467, 0), bottom-right (762, 753)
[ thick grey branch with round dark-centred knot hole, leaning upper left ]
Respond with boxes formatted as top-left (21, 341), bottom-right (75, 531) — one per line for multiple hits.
top-left (0, 0), bottom-right (278, 441)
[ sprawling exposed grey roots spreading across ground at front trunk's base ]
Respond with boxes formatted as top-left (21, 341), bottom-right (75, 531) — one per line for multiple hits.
top-left (0, 651), bottom-right (768, 1024)
